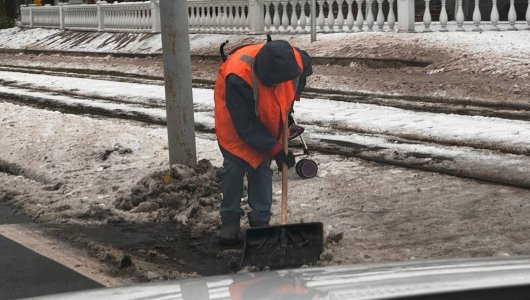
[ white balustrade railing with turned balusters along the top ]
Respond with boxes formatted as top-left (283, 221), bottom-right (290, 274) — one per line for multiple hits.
top-left (20, 0), bottom-right (530, 34)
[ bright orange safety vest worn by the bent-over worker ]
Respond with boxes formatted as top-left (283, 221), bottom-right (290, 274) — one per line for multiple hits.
top-left (210, 44), bottom-right (303, 168)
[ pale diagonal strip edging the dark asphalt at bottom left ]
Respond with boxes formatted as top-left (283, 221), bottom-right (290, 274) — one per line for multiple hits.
top-left (0, 224), bottom-right (130, 287)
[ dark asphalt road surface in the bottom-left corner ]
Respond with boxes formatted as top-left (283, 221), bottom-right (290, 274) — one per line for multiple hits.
top-left (0, 203), bottom-right (102, 300)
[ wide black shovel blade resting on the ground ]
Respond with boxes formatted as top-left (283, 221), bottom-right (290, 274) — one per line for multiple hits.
top-left (241, 222), bottom-right (324, 270)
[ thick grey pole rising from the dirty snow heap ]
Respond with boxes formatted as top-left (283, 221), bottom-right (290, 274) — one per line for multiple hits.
top-left (160, 0), bottom-right (197, 167)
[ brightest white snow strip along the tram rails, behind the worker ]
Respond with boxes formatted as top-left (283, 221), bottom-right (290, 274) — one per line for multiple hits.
top-left (0, 71), bottom-right (530, 153)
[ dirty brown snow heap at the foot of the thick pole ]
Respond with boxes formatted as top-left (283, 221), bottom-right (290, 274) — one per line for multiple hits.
top-left (115, 159), bottom-right (222, 231)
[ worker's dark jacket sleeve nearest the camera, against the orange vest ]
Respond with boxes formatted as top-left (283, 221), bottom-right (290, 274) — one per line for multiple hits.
top-left (226, 74), bottom-right (278, 154)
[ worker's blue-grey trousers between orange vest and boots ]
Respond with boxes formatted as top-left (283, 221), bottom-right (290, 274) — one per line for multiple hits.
top-left (221, 156), bottom-right (272, 226)
